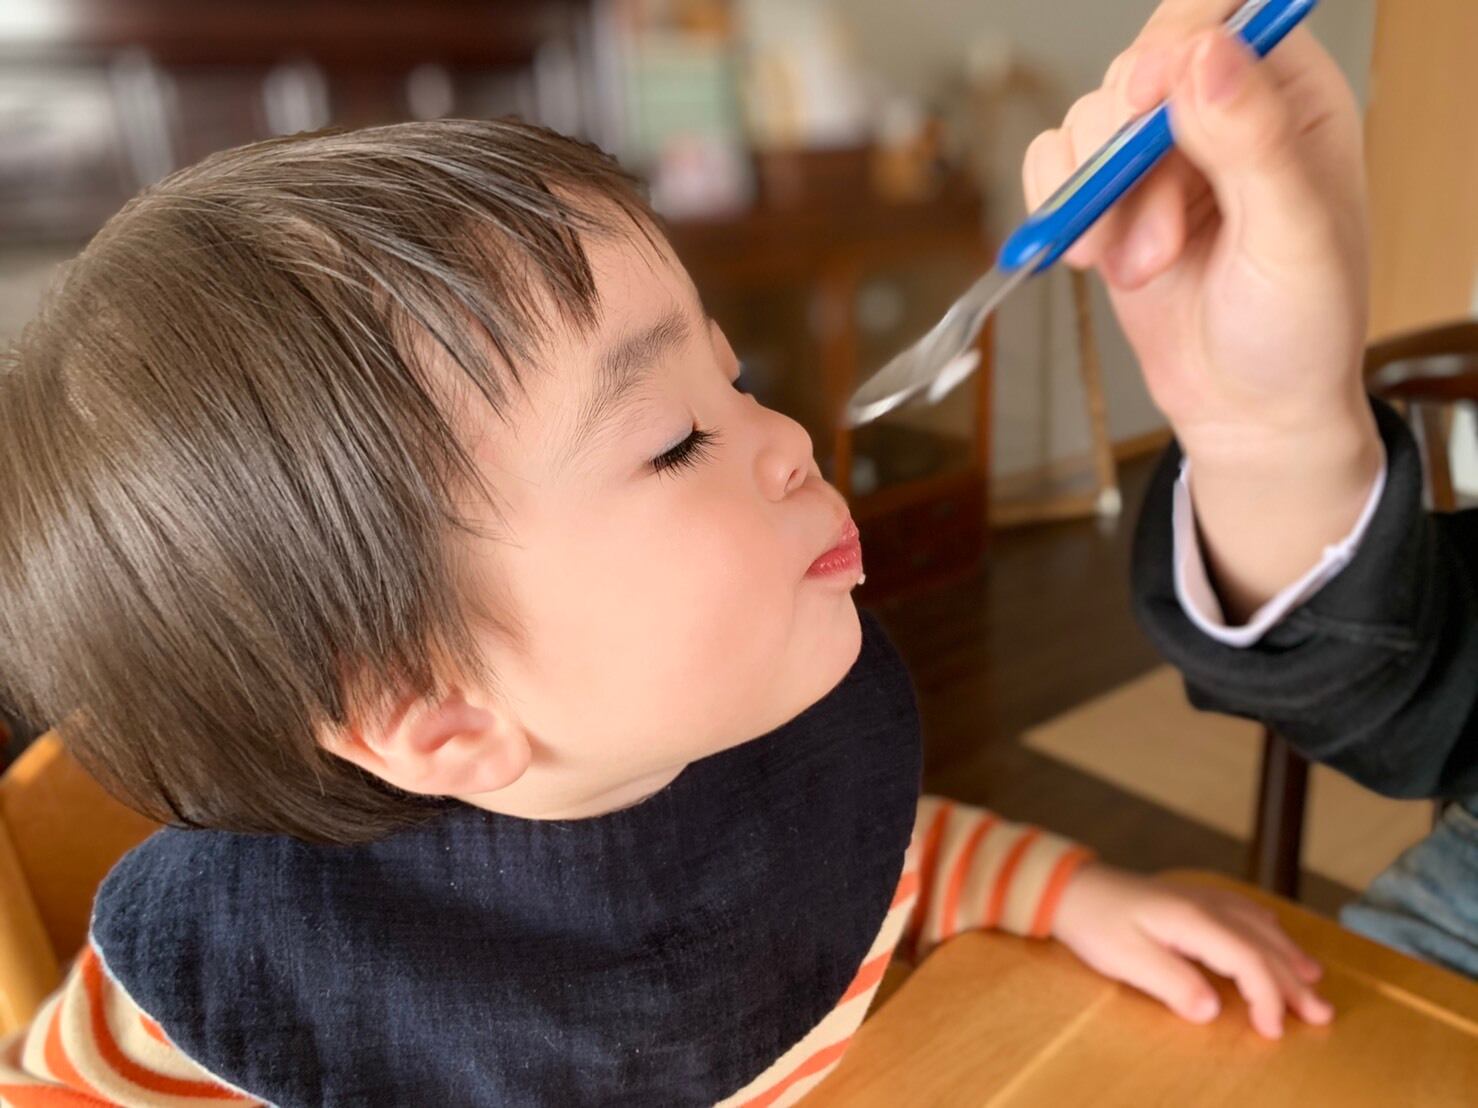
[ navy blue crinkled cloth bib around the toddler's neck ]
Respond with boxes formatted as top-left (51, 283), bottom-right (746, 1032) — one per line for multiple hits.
top-left (93, 615), bottom-right (921, 1108)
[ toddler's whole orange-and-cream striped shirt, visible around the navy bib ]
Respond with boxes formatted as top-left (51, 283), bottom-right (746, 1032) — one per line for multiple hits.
top-left (0, 796), bottom-right (1091, 1108)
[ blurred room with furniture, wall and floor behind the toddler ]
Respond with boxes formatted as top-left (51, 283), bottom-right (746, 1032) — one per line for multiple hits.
top-left (0, 0), bottom-right (1478, 907)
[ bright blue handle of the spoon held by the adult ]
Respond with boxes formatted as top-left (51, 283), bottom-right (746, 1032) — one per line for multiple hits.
top-left (998, 0), bottom-right (1318, 272)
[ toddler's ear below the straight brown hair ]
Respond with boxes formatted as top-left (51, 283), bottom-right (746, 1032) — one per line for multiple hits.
top-left (325, 690), bottom-right (534, 796)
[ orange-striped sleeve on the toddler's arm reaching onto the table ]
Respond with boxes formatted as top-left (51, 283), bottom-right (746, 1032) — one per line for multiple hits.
top-left (903, 796), bottom-right (1092, 960)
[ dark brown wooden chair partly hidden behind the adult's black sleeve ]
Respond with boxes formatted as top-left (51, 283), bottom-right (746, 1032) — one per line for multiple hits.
top-left (1247, 321), bottom-right (1478, 898)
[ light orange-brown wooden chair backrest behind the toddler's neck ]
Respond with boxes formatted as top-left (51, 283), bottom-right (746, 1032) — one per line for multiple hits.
top-left (0, 733), bottom-right (157, 1036)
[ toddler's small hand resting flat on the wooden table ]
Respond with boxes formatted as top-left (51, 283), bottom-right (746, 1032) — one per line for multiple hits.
top-left (1052, 863), bottom-right (1333, 1039)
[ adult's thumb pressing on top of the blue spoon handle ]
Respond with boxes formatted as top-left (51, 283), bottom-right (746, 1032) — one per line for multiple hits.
top-left (1171, 30), bottom-right (1329, 266)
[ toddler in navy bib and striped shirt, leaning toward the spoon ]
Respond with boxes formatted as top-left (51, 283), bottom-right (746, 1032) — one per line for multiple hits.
top-left (0, 45), bottom-right (1330, 1105)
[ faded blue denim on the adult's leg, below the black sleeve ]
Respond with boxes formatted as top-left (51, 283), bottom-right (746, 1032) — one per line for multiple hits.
top-left (1339, 796), bottom-right (1478, 979)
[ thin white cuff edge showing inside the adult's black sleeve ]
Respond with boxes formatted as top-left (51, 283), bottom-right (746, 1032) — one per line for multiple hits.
top-left (1171, 458), bottom-right (1386, 647)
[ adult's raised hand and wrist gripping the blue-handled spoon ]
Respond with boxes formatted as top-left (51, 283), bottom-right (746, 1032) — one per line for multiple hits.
top-left (1024, 0), bottom-right (1382, 616)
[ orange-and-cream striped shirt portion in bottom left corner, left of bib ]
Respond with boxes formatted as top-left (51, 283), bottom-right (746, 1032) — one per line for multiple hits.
top-left (0, 943), bottom-right (257, 1108)
